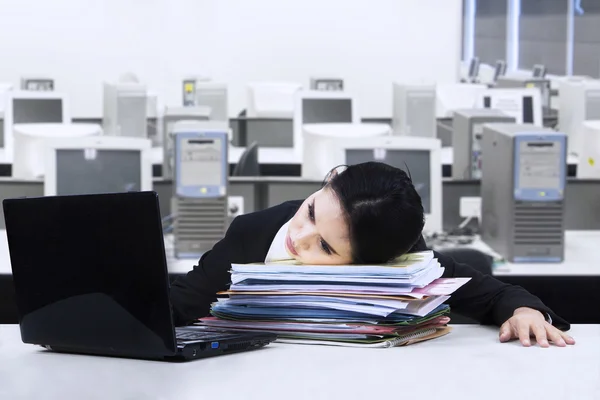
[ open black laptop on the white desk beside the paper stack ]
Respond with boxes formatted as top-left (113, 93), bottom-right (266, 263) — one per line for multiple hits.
top-left (3, 192), bottom-right (276, 360)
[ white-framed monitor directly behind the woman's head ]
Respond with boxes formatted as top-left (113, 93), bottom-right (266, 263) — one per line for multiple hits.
top-left (304, 136), bottom-right (442, 233)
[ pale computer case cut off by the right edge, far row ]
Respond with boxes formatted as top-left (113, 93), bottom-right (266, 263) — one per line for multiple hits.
top-left (558, 79), bottom-right (600, 155)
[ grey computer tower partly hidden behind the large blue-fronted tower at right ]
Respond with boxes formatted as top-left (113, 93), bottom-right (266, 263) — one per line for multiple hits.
top-left (452, 108), bottom-right (515, 180)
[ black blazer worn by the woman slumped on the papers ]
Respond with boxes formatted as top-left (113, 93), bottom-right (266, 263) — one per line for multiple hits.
top-left (171, 200), bottom-right (569, 329)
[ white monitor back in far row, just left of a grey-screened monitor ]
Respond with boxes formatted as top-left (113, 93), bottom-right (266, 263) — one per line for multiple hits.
top-left (246, 82), bottom-right (302, 119)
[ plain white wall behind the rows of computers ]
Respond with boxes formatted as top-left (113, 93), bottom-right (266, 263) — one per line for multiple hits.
top-left (0, 0), bottom-right (462, 118)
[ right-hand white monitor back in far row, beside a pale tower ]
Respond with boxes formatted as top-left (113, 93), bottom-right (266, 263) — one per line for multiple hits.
top-left (436, 83), bottom-right (488, 118)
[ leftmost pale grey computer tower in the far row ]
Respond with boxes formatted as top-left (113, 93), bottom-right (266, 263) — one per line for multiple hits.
top-left (102, 82), bottom-right (148, 138)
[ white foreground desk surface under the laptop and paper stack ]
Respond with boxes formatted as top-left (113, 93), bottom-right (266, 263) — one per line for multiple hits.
top-left (0, 325), bottom-right (600, 400)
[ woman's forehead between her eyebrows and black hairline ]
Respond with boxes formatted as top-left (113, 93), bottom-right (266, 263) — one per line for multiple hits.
top-left (313, 188), bottom-right (350, 252)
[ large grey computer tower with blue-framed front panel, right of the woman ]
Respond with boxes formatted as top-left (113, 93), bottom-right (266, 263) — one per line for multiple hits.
top-left (481, 123), bottom-right (567, 263)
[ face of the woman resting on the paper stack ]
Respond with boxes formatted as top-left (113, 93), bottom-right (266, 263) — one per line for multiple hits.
top-left (285, 187), bottom-right (352, 265)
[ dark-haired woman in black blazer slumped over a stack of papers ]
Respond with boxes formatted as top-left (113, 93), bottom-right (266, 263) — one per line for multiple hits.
top-left (171, 162), bottom-right (575, 347)
